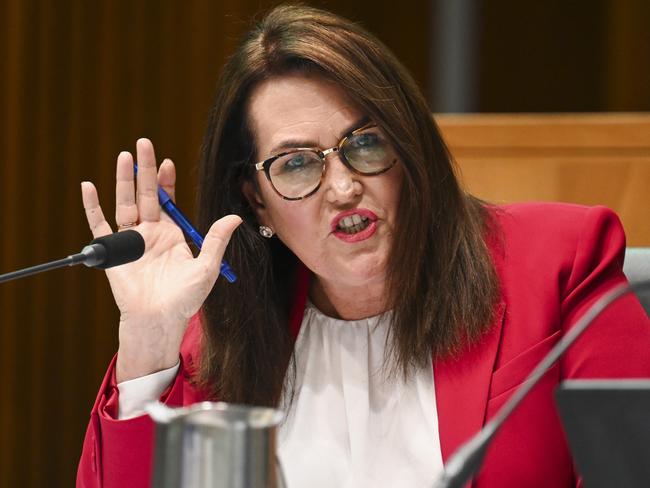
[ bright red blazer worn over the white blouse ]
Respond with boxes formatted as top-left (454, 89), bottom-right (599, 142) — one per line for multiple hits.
top-left (77, 203), bottom-right (650, 488)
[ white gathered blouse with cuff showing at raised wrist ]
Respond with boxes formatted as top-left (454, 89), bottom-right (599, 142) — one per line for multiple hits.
top-left (118, 304), bottom-right (442, 488)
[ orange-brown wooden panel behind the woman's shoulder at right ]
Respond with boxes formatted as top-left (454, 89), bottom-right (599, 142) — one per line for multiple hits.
top-left (436, 113), bottom-right (650, 246)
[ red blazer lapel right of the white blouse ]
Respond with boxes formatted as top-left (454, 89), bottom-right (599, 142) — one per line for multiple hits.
top-left (433, 300), bottom-right (506, 462)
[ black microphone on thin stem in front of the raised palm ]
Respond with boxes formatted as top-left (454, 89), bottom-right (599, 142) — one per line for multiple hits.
top-left (0, 230), bottom-right (145, 283)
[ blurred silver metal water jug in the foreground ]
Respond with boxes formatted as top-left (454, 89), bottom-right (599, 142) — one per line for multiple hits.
top-left (146, 402), bottom-right (286, 488)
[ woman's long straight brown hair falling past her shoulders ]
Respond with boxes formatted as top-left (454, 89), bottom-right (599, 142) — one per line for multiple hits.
top-left (192, 6), bottom-right (498, 405)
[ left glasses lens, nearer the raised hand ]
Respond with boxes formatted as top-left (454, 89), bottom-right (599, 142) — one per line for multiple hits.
top-left (269, 151), bottom-right (323, 198)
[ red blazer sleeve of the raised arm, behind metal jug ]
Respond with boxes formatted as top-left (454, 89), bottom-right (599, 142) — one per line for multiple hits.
top-left (77, 315), bottom-right (206, 488)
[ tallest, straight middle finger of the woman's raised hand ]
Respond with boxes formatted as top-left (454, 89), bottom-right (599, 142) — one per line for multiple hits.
top-left (136, 139), bottom-right (160, 222)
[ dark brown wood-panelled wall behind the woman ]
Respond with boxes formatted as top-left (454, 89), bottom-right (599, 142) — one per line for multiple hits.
top-left (0, 0), bottom-right (650, 487)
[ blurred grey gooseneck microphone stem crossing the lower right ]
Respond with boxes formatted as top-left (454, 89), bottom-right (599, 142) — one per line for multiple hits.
top-left (434, 280), bottom-right (650, 488)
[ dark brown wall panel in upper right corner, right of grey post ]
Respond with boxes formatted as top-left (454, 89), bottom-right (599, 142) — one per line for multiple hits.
top-left (470, 0), bottom-right (650, 112)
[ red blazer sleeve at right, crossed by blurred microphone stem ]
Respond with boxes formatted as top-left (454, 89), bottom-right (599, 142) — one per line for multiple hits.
top-left (560, 207), bottom-right (650, 378)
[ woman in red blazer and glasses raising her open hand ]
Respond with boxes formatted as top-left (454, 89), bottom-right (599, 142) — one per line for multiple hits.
top-left (77, 7), bottom-right (650, 487)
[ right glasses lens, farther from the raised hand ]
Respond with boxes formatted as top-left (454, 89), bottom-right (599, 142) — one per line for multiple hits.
top-left (341, 127), bottom-right (395, 174)
